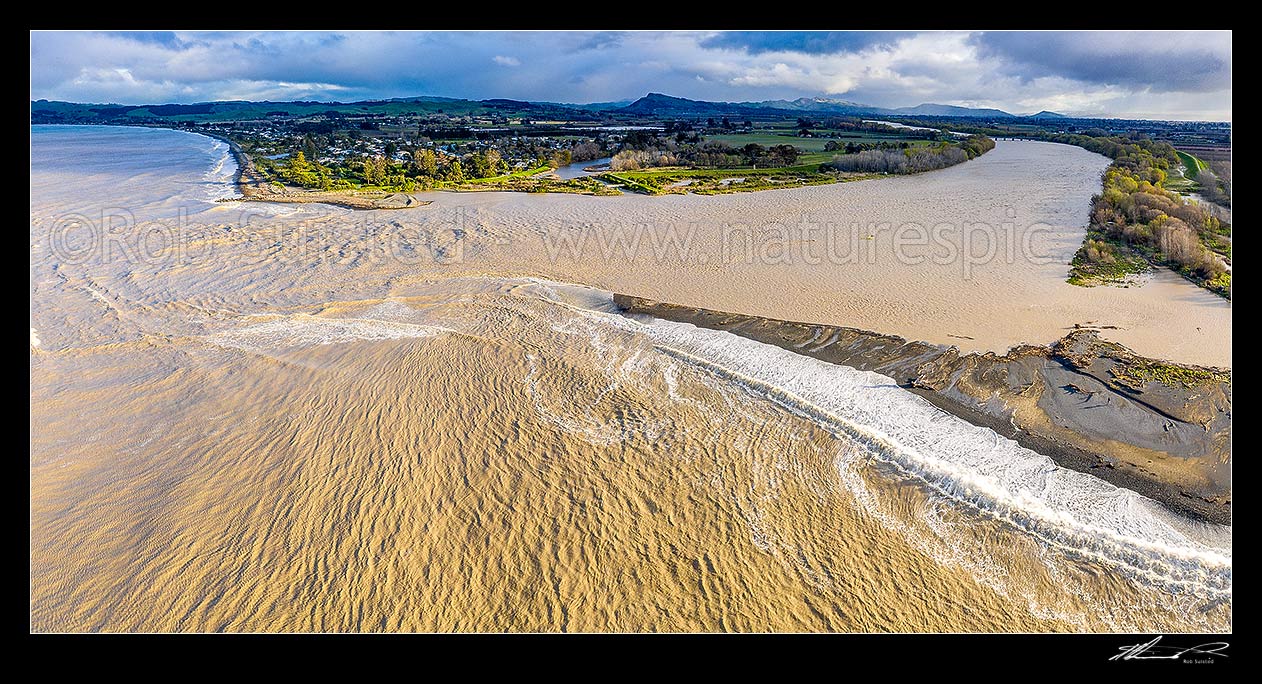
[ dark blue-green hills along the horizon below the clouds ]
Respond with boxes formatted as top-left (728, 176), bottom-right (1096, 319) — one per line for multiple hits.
top-left (30, 92), bottom-right (1068, 124)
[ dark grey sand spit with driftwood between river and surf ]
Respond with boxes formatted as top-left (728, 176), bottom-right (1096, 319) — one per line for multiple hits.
top-left (613, 294), bottom-right (1232, 525)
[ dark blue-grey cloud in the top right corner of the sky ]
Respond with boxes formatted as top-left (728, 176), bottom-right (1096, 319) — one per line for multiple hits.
top-left (972, 32), bottom-right (1232, 92)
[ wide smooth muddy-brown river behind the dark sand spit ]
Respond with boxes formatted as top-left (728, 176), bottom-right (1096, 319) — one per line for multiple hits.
top-left (382, 141), bottom-right (1230, 366)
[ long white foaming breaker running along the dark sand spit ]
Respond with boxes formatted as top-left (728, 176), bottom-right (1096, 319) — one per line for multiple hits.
top-left (642, 321), bottom-right (1232, 596)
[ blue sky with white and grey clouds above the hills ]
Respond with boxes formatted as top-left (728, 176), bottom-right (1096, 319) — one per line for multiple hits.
top-left (30, 32), bottom-right (1232, 121)
